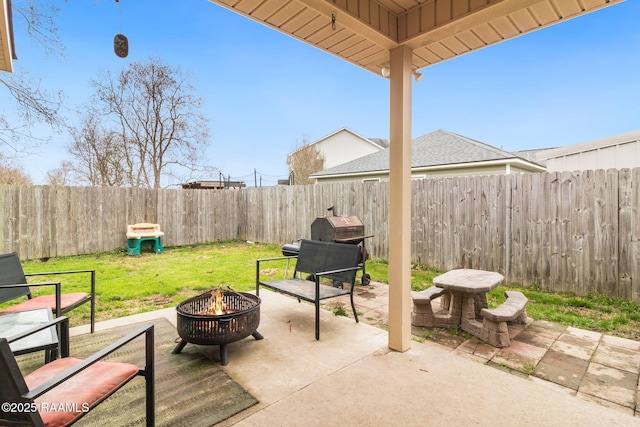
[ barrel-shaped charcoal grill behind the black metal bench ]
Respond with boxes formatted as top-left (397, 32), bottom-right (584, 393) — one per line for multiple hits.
top-left (282, 206), bottom-right (373, 285)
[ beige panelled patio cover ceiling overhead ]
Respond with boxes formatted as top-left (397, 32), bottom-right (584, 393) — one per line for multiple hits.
top-left (210, 0), bottom-right (622, 74)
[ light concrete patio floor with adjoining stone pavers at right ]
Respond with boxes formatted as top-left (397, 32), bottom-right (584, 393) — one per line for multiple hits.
top-left (72, 283), bottom-right (640, 427)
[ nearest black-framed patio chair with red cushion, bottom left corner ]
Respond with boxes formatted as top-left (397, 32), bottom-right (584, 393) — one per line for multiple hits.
top-left (0, 319), bottom-right (155, 426)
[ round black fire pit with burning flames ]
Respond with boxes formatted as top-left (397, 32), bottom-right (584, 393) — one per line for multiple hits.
top-left (172, 288), bottom-right (262, 365)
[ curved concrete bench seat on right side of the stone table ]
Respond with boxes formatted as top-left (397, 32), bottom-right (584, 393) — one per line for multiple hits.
top-left (480, 291), bottom-right (529, 347)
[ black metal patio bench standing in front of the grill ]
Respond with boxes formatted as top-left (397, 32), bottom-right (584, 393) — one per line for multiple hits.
top-left (256, 240), bottom-right (362, 340)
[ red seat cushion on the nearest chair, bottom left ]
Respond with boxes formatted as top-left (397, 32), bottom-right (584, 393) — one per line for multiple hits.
top-left (24, 357), bottom-right (138, 427)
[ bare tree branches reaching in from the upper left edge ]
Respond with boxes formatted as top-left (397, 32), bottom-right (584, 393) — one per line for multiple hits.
top-left (0, 0), bottom-right (63, 160)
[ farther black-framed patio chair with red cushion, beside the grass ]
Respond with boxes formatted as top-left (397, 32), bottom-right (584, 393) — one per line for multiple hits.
top-left (0, 252), bottom-right (96, 333)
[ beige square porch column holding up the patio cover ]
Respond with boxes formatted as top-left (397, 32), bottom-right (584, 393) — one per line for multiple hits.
top-left (389, 46), bottom-right (412, 351)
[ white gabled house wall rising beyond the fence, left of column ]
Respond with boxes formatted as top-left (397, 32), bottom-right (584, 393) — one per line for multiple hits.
top-left (289, 128), bottom-right (385, 169)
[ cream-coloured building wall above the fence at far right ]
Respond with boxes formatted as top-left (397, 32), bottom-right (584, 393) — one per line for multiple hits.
top-left (538, 131), bottom-right (640, 172)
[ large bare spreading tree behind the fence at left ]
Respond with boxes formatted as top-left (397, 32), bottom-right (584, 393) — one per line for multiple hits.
top-left (78, 57), bottom-right (209, 188)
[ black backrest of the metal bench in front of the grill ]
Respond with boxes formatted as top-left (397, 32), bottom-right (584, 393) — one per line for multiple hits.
top-left (295, 240), bottom-right (361, 284)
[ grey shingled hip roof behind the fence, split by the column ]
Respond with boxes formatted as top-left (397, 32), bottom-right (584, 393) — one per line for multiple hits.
top-left (311, 130), bottom-right (542, 178)
